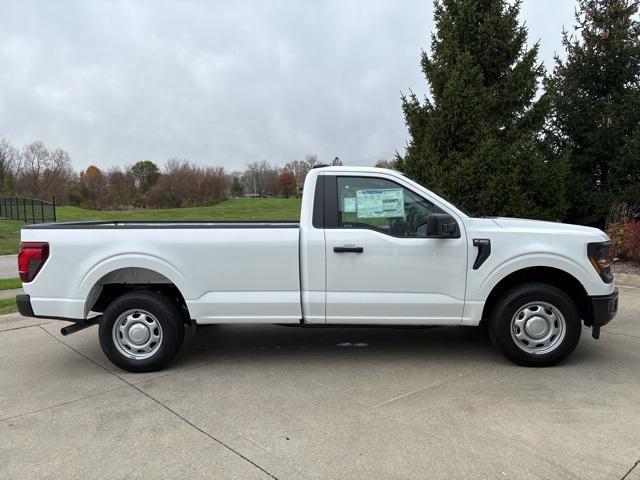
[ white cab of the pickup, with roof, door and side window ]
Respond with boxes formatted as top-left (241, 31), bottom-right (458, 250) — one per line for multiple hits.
top-left (300, 167), bottom-right (468, 325)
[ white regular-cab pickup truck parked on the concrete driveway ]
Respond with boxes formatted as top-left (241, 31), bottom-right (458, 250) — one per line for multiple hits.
top-left (17, 167), bottom-right (618, 372)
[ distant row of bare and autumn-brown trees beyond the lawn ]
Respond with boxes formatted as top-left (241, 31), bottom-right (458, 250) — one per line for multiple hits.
top-left (0, 138), bottom-right (342, 210)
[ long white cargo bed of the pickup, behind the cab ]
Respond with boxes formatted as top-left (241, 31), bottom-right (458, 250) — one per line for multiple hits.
top-left (22, 221), bottom-right (302, 324)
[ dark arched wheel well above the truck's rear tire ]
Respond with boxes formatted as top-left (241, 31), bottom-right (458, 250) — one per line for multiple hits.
top-left (86, 268), bottom-right (191, 323)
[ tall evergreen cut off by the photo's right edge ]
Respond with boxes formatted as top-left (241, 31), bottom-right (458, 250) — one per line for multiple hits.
top-left (547, 0), bottom-right (640, 227)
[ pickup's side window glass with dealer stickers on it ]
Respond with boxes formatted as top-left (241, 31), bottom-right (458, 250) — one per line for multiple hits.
top-left (337, 177), bottom-right (442, 237)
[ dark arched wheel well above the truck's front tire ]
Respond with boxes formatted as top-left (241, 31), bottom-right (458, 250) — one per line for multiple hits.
top-left (482, 267), bottom-right (593, 326)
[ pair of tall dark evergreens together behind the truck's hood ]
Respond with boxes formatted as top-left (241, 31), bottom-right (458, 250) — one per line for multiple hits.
top-left (396, 0), bottom-right (640, 227)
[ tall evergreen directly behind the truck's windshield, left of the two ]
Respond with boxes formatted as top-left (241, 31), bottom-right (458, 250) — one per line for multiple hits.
top-left (397, 0), bottom-right (566, 219)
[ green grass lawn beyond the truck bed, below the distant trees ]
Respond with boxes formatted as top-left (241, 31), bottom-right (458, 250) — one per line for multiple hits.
top-left (0, 198), bottom-right (301, 255)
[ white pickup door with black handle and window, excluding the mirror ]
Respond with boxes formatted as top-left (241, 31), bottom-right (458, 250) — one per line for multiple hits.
top-left (324, 173), bottom-right (467, 325)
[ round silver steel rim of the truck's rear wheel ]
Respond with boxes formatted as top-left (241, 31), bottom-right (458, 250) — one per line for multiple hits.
top-left (112, 309), bottom-right (162, 360)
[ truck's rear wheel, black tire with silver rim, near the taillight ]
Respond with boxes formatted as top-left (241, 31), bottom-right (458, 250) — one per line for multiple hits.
top-left (99, 290), bottom-right (184, 372)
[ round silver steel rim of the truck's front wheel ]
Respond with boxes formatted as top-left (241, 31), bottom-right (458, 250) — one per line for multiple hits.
top-left (511, 302), bottom-right (567, 355)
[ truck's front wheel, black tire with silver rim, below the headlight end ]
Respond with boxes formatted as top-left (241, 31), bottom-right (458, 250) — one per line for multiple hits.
top-left (489, 283), bottom-right (582, 367)
